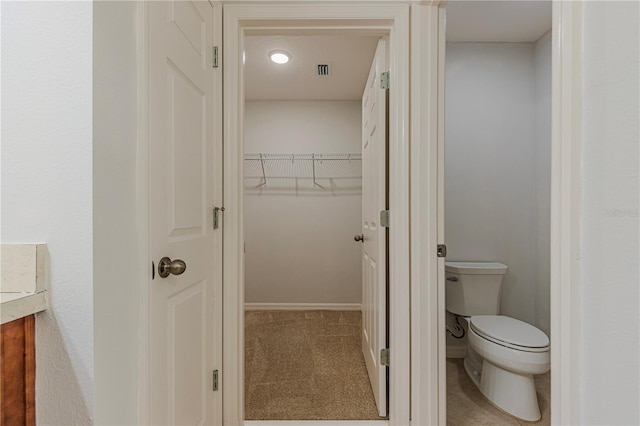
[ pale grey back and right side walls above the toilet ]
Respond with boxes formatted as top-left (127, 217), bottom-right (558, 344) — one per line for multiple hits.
top-left (445, 39), bottom-right (551, 344)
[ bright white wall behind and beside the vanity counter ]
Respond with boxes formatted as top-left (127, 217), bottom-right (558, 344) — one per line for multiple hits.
top-left (1, 2), bottom-right (94, 425)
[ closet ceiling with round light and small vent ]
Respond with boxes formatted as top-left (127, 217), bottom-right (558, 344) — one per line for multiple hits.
top-left (245, 35), bottom-right (378, 100)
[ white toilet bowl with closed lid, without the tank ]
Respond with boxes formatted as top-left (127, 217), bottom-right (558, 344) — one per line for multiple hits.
top-left (465, 315), bottom-right (550, 422)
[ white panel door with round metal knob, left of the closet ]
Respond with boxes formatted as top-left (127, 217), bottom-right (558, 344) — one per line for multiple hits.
top-left (147, 1), bottom-right (222, 425)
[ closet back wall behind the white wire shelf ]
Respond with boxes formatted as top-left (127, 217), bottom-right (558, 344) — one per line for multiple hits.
top-left (245, 101), bottom-right (362, 303)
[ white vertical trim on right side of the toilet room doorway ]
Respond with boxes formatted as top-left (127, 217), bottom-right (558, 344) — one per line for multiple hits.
top-left (550, 1), bottom-right (583, 425)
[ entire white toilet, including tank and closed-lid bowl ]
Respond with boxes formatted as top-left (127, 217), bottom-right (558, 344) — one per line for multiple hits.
top-left (445, 262), bottom-right (551, 422)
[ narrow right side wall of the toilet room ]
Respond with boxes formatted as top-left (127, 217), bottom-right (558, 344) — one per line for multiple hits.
top-left (533, 31), bottom-right (551, 336)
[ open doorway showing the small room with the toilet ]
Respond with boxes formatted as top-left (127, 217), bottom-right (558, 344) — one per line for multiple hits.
top-left (444, 1), bottom-right (552, 425)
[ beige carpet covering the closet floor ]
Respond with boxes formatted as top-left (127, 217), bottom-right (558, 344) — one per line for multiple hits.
top-left (245, 311), bottom-right (380, 420)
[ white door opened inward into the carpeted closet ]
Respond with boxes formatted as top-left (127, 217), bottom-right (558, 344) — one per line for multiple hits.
top-left (362, 40), bottom-right (388, 416)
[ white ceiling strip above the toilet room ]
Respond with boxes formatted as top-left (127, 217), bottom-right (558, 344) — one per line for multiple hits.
top-left (446, 0), bottom-right (551, 43)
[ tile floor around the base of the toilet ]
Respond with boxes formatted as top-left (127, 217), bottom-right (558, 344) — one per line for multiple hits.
top-left (447, 358), bottom-right (551, 426)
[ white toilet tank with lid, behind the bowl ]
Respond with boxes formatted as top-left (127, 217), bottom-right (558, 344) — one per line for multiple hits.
top-left (444, 262), bottom-right (507, 316)
